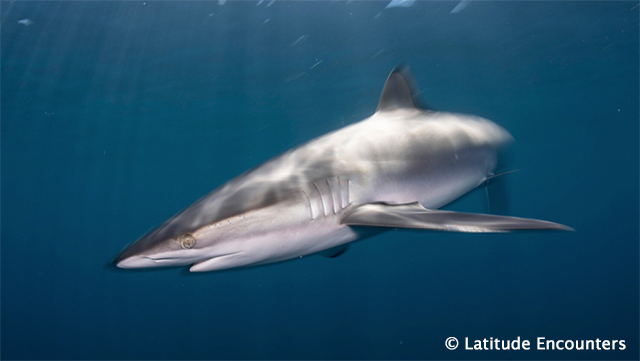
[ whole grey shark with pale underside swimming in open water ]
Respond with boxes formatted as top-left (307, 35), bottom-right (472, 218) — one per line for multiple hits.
top-left (115, 67), bottom-right (570, 272)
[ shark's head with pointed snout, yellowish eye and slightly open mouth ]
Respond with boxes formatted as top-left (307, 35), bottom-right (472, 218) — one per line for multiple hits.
top-left (114, 160), bottom-right (310, 272)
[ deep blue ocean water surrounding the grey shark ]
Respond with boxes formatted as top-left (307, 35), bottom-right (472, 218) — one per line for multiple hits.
top-left (0, 0), bottom-right (640, 360)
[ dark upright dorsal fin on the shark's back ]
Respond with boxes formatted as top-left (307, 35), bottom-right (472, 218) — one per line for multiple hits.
top-left (376, 65), bottom-right (429, 112)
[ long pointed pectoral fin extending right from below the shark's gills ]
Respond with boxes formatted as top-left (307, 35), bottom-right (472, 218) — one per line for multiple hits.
top-left (341, 202), bottom-right (573, 233)
